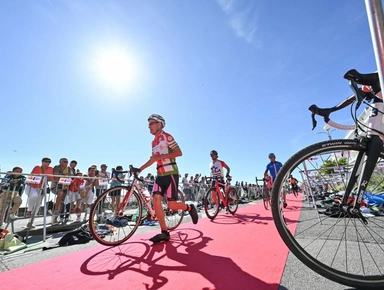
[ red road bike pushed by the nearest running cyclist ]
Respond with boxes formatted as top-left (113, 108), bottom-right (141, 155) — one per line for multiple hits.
top-left (89, 165), bottom-right (185, 246)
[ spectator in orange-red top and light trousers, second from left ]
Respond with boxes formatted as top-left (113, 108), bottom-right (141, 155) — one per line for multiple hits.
top-left (25, 157), bottom-right (53, 228)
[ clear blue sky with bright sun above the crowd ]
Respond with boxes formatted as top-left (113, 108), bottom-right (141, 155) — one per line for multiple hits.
top-left (0, 0), bottom-right (376, 182)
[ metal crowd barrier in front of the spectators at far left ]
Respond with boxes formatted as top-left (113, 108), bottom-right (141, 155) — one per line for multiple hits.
top-left (0, 172), bottom-right (117, 241)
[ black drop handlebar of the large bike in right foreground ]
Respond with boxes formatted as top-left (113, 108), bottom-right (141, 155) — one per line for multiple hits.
top-left (308, 69), bottom-right (381, 130)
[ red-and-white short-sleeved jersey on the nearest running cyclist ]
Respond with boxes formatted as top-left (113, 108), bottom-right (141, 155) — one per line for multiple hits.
top-left (152, 131), bottom-right (179, 176)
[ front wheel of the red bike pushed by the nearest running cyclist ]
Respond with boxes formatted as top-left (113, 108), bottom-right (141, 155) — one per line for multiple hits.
top-left (89, 186), bottom-right (143, 246)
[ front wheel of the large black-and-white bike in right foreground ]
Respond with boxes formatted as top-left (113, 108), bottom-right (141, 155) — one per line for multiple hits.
top-left (272, 140), bottom-right (384, 289)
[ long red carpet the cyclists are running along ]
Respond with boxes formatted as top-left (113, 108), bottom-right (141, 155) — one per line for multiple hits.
top-left (0, 195), bottom-right (300, 290)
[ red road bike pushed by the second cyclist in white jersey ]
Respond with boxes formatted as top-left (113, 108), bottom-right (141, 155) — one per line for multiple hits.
top-left (204, 177), bottom-right (239, 220)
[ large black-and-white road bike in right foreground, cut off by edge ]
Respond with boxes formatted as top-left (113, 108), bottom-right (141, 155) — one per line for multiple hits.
top-left (272, 70), bottom-right (384, 289)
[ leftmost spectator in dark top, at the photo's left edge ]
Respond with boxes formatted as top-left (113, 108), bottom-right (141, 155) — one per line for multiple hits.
top-left (0, 166), bottom-right (26, 225)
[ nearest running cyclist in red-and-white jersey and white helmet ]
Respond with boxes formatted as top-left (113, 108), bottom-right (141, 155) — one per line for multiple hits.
top-left (140, 114), bottom-right (199, 243)
